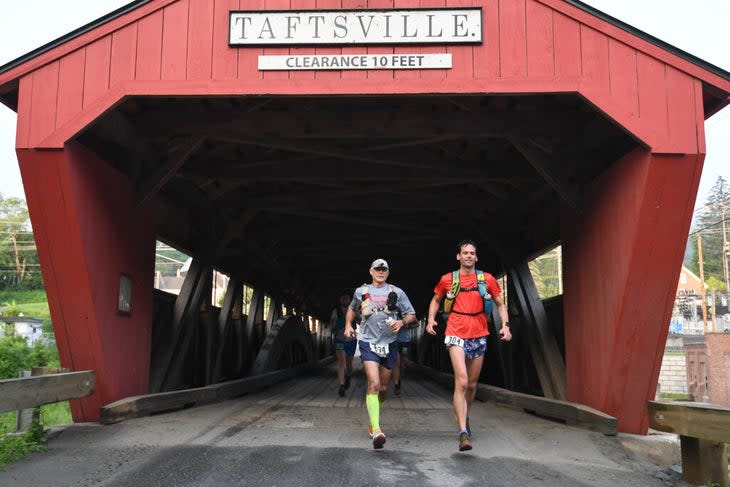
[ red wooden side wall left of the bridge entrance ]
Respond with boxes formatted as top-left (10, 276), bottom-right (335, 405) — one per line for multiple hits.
top-left (18, 143), bottom-right (155, 421)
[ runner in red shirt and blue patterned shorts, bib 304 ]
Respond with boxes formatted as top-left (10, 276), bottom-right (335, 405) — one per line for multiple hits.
top-left (426, 240), bottom-right (512, 451)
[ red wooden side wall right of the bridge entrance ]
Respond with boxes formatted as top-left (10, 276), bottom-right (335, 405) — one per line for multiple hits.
top-left (563, 150), bottom-right (703, 433)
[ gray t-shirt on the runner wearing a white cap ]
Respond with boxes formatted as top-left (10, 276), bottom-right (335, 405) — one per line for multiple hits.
top-left (350, 283), bottom-right (416, 344)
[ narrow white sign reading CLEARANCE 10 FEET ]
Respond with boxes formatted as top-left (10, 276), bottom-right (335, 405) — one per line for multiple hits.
top-left (259, 54), bottom-right (451, 71)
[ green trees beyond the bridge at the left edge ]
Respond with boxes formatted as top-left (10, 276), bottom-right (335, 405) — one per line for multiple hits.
top-left (0, 195), bottom-right (42, 289)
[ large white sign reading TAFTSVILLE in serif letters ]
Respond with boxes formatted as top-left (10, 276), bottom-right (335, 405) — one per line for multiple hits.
top-left (228, 7), bottom-right (482, 46)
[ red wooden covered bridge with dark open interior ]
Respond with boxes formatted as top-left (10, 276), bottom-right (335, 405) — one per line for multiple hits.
top-left (0, 0), bottom-right (730, 433)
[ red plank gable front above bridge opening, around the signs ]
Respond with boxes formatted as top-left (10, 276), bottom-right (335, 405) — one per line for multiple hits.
top-left (11, 0), bottom-right (716, 153)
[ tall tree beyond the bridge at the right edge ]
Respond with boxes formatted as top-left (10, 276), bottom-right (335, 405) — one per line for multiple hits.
top-left (685, 176), bottom-right (730, 292)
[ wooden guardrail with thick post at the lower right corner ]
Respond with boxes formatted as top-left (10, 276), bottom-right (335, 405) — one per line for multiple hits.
top-left (649, 401), bottom-right (730, 487)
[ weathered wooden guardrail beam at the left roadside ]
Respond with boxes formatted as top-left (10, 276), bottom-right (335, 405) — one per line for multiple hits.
top-left (0, 370), bottom-right (96, 413)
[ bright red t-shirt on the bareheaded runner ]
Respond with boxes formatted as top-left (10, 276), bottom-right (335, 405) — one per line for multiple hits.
top-left (433, 272), bottom-right (502, 338)
